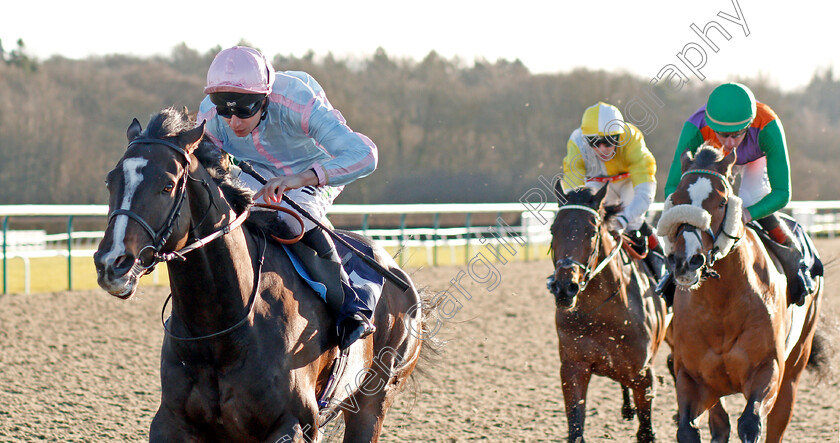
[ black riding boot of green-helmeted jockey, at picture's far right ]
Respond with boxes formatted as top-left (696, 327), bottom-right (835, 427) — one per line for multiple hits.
top-left (758, 215), bottom-right (816, 306)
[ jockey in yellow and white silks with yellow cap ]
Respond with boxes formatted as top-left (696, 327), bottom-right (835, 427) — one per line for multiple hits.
top-left (562, 102), bottom-right (663, 288)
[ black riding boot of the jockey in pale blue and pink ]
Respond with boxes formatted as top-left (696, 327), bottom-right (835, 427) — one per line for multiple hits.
top-left (296, 228), bottom-right (376, 350)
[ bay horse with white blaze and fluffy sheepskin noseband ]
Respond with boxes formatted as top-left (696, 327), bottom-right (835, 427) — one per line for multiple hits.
top-left (658, 146), bottom-right (822, 442)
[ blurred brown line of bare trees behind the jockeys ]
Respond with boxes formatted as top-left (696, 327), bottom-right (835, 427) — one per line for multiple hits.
top-left (0, 42), bottom-right (840, 204)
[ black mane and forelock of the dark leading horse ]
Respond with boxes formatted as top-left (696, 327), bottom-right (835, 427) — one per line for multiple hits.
top-left (141, 107), bottom-right (253, 214)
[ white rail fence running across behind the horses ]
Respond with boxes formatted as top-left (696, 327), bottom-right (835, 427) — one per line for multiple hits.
top-left (0, 201), bottom-right (840, 293)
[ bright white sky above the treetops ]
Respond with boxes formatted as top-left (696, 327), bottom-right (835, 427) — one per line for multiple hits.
top-left (0, 0), bottom-right (840, 91)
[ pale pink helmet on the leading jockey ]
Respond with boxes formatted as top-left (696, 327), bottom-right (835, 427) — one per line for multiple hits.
top-left (204, 46), bottom-right (275, 94)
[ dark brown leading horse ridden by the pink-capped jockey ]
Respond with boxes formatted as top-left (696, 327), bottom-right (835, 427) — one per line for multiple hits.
top-left (95, 108), bottom-right (423, 442)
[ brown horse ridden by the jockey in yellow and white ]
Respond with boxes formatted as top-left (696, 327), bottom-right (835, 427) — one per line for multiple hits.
top-left (549, 181), bottom-right (668, 443)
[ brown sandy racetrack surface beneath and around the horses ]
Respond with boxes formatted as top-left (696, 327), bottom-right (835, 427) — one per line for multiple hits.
top-left (0, 240), bottom-right (840, 442)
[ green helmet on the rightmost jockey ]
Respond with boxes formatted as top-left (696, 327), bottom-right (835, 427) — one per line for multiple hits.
top-left (706, 83), bottom-right (755, 132)
